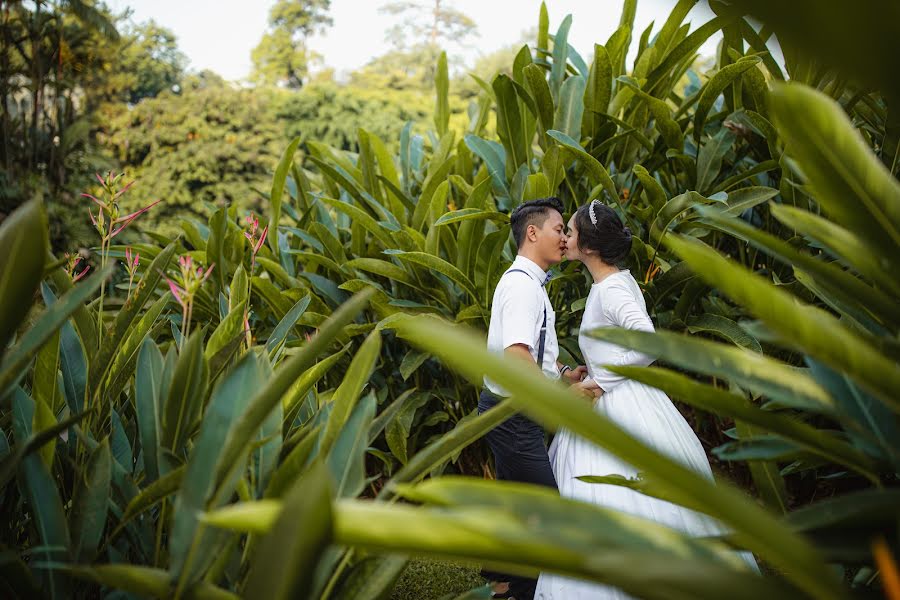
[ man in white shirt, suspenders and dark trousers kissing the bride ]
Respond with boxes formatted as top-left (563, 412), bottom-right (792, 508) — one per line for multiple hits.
top-left (478, 198), bottom-right (587, 600)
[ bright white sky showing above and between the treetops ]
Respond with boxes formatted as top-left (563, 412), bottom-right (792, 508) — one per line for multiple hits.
top-left (108, 0), bottom-right (719, 80)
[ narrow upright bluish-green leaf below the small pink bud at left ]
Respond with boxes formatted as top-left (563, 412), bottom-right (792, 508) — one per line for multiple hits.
top-left (134, 338), bottom-right (163, 483)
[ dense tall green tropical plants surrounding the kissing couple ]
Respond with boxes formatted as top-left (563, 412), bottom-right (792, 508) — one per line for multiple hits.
top-left (0, 0), bottom-right (900, 598)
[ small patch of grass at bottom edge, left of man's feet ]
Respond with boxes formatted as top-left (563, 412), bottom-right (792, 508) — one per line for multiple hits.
top-left (391, 558), bottom-right (487, 600)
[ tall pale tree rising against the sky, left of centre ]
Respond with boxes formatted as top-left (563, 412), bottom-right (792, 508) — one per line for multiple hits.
top-left (251, 0), bottom-right (332, 88)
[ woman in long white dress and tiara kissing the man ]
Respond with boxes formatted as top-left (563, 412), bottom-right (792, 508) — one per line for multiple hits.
top-left (535, 200), bottom-right (757, 600)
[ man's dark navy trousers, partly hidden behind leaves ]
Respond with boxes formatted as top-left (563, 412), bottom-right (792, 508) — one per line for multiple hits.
top-left (478, 390), bottom-right (557, 600)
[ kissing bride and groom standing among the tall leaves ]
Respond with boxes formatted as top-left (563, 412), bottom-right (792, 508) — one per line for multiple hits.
top-left (478, 198), bottom-right (756, 600)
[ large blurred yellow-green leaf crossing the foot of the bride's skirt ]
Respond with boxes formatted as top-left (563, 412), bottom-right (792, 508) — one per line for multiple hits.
top-left (335, 492), bottom-right (797, 600)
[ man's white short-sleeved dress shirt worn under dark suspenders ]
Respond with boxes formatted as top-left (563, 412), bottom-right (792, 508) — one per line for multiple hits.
top-left (484, 256), bottom-right (559, 396)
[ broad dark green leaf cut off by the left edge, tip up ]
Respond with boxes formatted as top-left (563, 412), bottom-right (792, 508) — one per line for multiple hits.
top-left (0, 200), bottom-right (46, 360)
